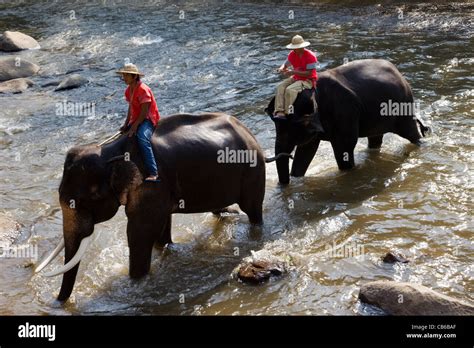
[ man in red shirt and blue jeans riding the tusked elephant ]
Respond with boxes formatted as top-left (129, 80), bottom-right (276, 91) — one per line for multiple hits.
top-left (117, 63), bottom-right (160, 182)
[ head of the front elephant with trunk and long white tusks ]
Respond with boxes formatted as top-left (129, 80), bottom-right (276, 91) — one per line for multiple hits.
top-left (35, 140), bottom-right (142, 301)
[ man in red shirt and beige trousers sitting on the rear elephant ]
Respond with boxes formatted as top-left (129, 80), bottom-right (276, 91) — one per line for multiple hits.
top-left (274, 35), bottom-right (318, 118)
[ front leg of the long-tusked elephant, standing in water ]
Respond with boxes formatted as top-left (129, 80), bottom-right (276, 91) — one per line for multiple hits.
top-left (127, 215), bottom-right (168, 278)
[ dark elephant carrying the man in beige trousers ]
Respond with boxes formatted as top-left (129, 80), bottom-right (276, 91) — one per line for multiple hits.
top-left (265, 59), bottom-right (429, 185)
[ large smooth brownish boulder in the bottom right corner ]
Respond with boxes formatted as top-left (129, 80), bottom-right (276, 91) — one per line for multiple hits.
top-left (359, 280), bottom-right (474, 315)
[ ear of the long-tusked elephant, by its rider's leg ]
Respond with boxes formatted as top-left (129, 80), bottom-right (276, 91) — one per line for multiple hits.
top-left (108, 156), bottom-right (143, 205)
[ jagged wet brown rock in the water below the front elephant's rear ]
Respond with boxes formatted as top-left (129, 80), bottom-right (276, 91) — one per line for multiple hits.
top-left (234, 250), bottom-right (288, 284)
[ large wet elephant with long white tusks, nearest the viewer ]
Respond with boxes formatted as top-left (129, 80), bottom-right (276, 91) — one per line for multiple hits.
top-left (36, 113), bottom-right (265, 301)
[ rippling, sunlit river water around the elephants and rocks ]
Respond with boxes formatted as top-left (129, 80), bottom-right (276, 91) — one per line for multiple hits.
top-left (0, 0), bottom-right (474, 315)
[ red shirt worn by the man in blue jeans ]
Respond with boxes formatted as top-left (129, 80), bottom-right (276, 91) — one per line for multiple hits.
top-left (125, 81), bottom-right (160, 126)
